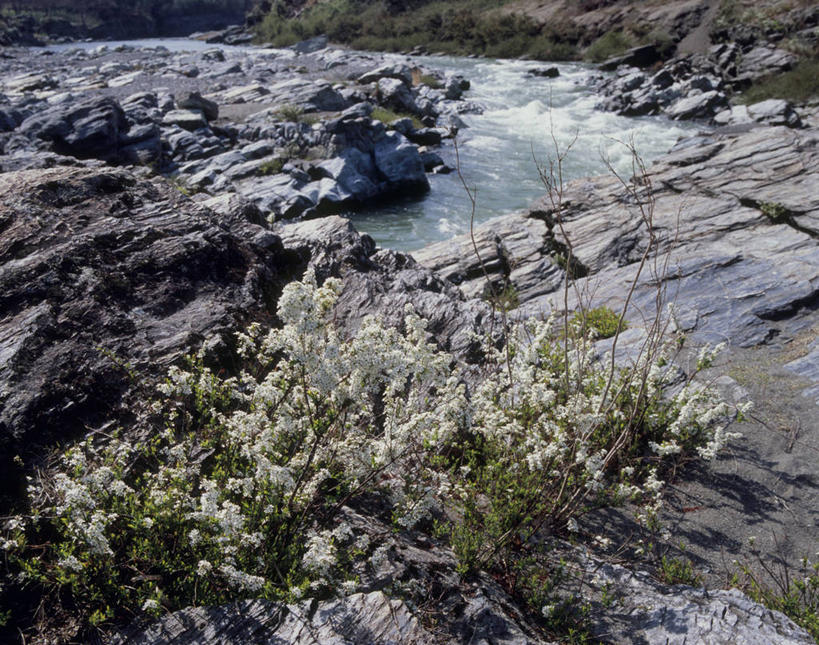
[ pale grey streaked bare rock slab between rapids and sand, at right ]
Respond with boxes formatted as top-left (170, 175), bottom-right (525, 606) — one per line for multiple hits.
top-left (414, 119), bottom-right (819, 346)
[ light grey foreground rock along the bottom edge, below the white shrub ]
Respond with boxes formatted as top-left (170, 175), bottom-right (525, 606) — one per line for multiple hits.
top-left (114, 508), bottom-right (813, 645)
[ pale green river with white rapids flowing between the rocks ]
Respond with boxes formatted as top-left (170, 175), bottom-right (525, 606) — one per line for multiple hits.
top-left (48, 39), bottom-right (697, 251)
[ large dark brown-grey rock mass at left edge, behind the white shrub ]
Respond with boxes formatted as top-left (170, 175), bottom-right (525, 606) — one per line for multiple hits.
top-left (0, 167), bottom-right (298, 508)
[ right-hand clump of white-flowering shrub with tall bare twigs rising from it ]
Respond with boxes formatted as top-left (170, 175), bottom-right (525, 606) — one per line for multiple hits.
top-left (442, 318), bottom-right (737, 570)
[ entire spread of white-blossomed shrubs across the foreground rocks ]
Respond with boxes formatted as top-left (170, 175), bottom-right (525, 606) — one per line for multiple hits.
top-left (3, 274), bottom-right (744, 623)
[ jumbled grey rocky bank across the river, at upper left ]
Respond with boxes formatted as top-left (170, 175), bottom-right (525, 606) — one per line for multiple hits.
top-left (0, 40), bottom-right (480, 219)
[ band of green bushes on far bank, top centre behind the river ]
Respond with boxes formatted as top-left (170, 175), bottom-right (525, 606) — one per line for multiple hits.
top-left (258, 0), bottom-right (577, 60)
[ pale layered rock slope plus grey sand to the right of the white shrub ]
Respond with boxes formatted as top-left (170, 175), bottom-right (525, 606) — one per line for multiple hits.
top-left (413, 110), bottom-right (819, 612)
